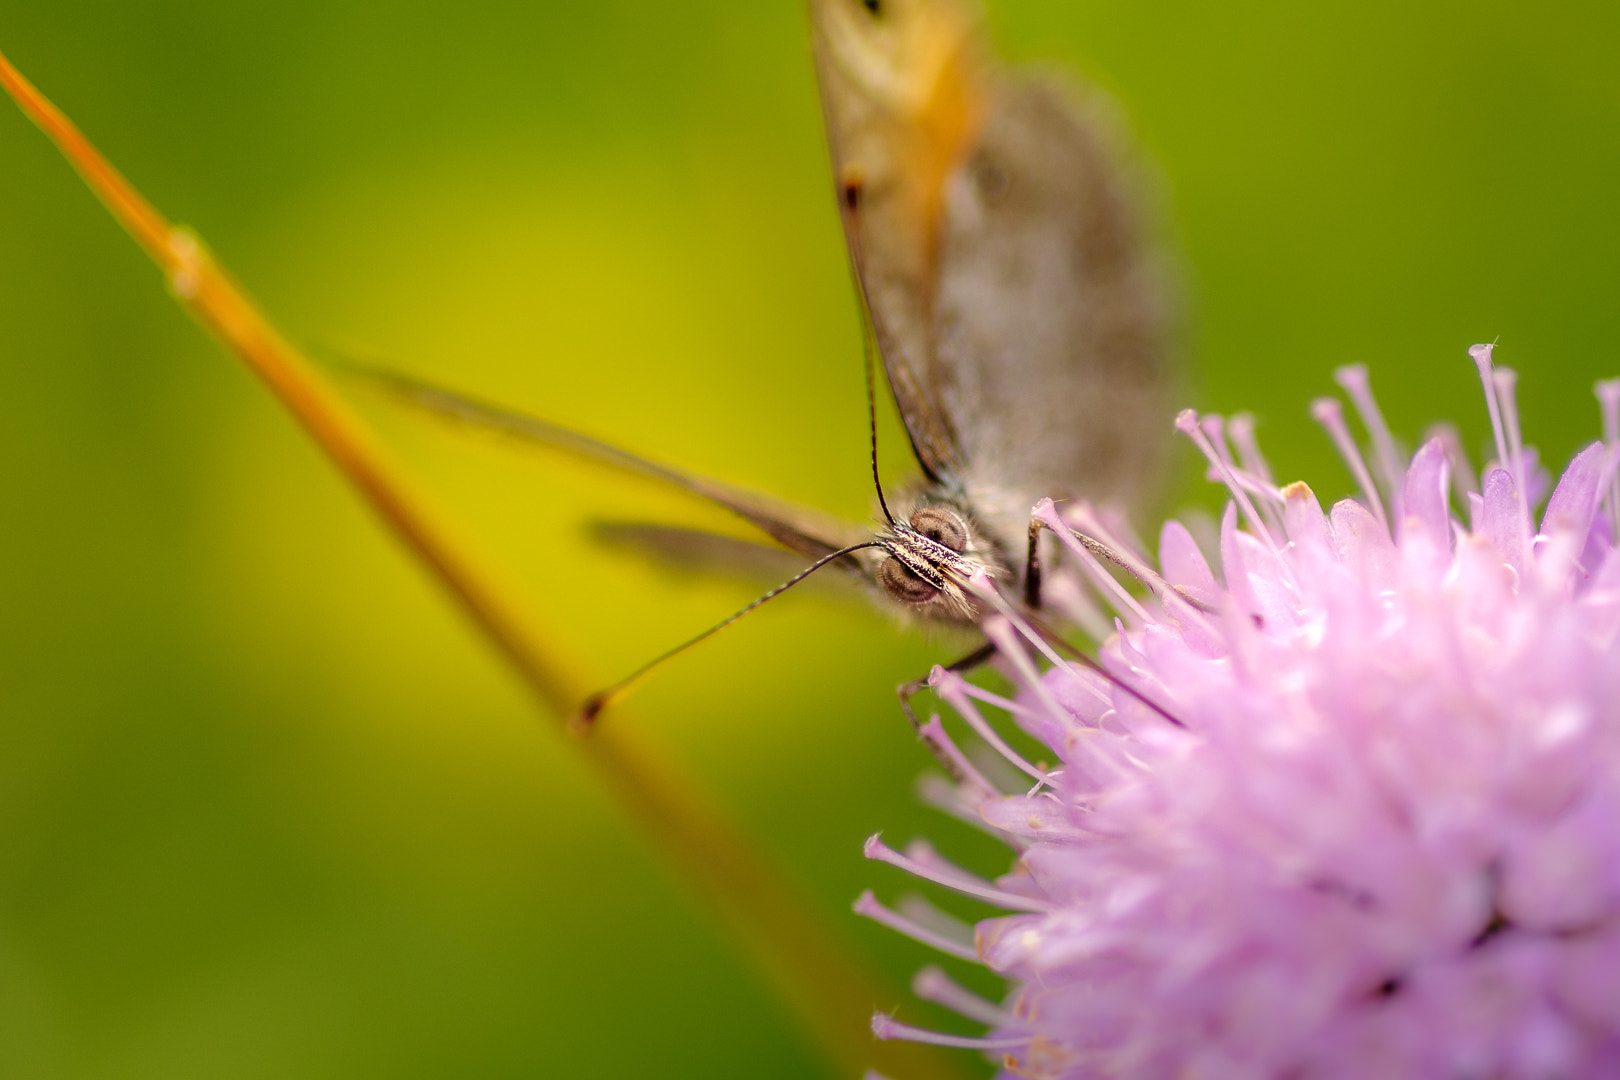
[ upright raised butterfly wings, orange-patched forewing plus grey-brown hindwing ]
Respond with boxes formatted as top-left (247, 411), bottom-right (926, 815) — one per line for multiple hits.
top-left (810, 0), bottom-right (1168, 551)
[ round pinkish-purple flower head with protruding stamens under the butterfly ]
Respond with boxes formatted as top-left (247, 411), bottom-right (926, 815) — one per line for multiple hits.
top-left (857, 347), bottom-right (1620, 1080)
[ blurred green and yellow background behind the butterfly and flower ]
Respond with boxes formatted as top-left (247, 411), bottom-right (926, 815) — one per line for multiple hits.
top-left (0, 0), bottom-right (1620, 1077)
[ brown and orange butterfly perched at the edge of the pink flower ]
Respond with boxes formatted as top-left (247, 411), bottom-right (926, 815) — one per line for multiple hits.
top-left (354, 0), bottom-right (1171, 744)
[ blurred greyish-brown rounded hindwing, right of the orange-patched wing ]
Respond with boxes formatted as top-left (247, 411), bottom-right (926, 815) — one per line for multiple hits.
top-left (932, 76), bottom-right (1171, 538)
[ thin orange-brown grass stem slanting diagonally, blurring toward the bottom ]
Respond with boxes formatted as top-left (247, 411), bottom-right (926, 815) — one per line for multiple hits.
top-left (0, 46), bottom-right (962, 1078)
